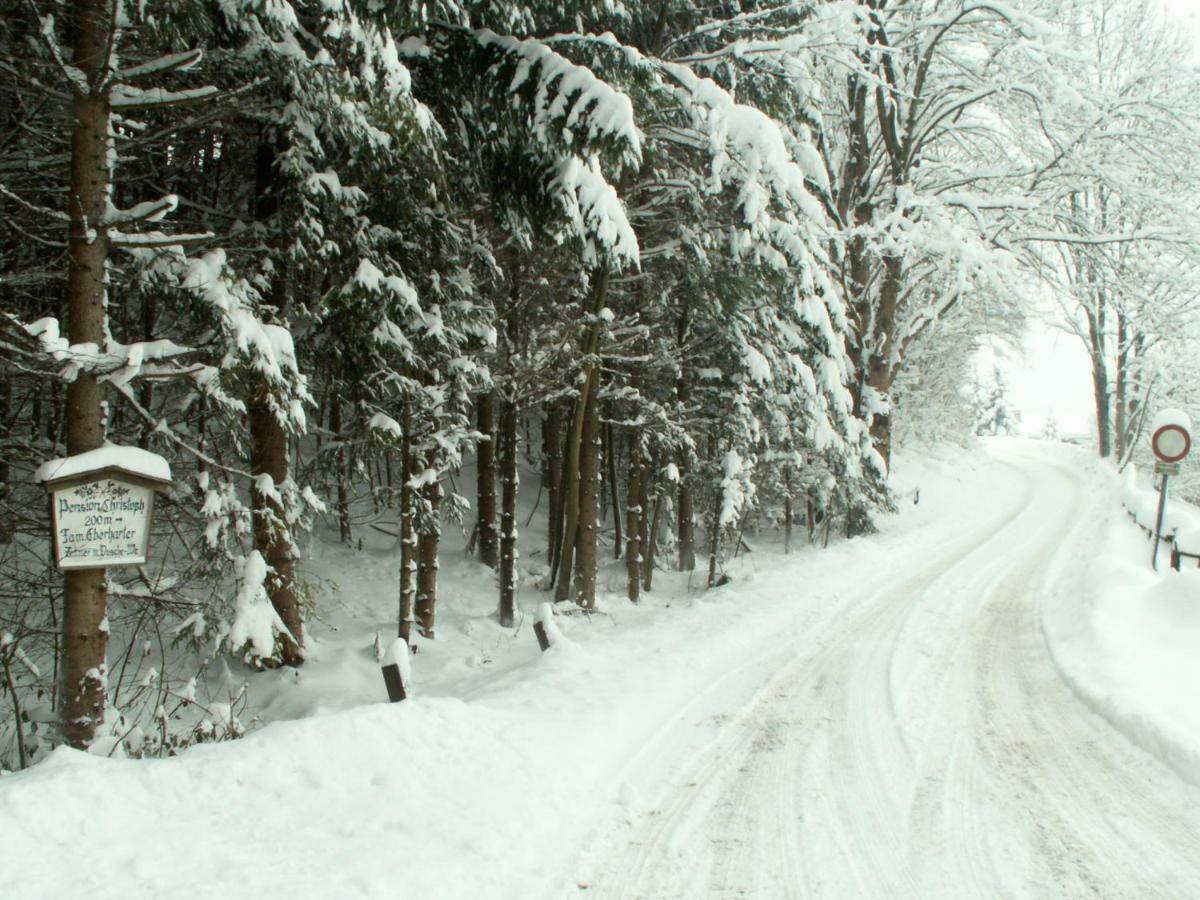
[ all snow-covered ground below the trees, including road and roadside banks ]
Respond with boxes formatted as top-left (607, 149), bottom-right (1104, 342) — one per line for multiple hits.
top-left (0, 442), bottom-right (1200, 898)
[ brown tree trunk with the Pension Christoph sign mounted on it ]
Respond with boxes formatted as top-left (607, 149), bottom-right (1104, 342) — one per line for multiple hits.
top-left (60, 0), bottom-right (114, 749)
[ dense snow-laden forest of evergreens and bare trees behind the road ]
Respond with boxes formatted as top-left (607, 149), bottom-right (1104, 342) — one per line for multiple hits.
top-left (0, 0), bottom-right (1200, 768)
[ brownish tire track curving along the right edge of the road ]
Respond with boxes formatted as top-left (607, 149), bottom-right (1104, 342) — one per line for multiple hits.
top-left (977, 460), bottom-right (1200, 898)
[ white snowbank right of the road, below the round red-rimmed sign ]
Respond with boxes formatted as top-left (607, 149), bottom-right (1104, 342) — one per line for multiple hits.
top-left (1043, 453), bottom-right (1200, 785)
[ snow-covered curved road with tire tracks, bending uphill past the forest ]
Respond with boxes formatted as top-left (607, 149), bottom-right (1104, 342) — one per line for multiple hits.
top-left (588, 450), bottom-right (1200, 899)
